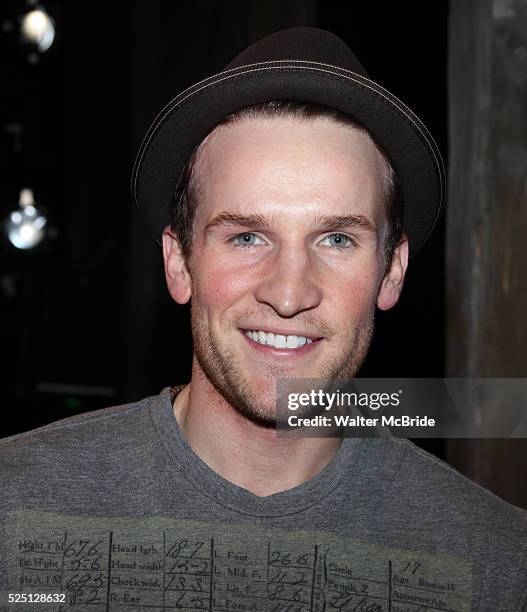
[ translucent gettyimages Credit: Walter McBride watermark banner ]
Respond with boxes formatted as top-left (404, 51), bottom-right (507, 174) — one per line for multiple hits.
top-left (277, 378), bottom-right (527, 438)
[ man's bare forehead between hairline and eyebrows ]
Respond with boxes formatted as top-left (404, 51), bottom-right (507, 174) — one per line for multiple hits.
top-left (195, 117), bottom-right (387, 219)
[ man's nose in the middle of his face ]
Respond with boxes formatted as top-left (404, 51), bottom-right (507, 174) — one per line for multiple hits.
top-left (254, 245), bottom-right (322, 317)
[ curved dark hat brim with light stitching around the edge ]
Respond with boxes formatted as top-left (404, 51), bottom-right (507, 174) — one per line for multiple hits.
top-left (132, 60), bottom-right (445, 256)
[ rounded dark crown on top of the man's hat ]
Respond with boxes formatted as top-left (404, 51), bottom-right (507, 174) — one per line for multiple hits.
top-left (226, 27), bottom-right (368, 77)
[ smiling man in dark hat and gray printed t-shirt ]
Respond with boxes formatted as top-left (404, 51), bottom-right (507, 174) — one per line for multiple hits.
top-left (0, 28), bottom-right (527, 612)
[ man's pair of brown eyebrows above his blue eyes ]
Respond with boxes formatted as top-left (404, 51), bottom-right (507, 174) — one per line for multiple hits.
top-left (203, 212), bottom-right (377, 235)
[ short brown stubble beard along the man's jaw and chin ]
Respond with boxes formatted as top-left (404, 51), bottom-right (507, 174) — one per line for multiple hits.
top-left (191, 300), bottom-right (374, 428)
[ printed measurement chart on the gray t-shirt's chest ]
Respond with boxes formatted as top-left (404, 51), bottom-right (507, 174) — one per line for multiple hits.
top-left (0, 511), bottom-right (472, 612)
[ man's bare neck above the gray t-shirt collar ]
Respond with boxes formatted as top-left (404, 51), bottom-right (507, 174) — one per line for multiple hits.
top-left (174, 366), bottom-right (341, 497)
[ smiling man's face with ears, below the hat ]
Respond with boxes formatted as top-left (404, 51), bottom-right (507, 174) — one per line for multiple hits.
top-left (164, 118), bottom-right (406, 424)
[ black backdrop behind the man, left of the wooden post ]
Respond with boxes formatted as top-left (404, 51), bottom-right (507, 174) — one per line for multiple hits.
top-left (0, 0), bottom-right (448, 456)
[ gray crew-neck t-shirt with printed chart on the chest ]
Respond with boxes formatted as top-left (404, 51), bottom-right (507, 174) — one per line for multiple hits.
top-left (0, 388), bottom-right (527, 612)
